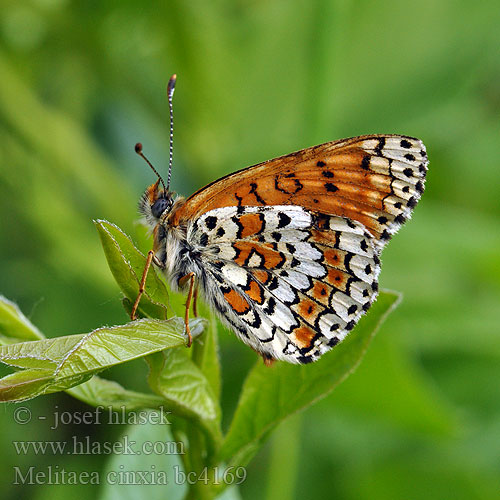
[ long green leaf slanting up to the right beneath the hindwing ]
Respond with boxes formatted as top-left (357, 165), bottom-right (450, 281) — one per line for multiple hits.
top-left (219, 292), bottom-right (399, 465)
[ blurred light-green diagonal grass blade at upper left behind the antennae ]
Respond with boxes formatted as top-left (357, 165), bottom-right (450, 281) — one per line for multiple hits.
top-left (0, 51), bottom-right (134, 228)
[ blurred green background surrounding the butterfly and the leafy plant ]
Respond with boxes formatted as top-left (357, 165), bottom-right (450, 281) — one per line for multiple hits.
top-left (0, 0), bottom-right (500, 500)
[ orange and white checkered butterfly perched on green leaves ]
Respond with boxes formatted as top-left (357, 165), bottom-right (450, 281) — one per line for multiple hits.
top-left (134, 75), bottom-right (428, 363)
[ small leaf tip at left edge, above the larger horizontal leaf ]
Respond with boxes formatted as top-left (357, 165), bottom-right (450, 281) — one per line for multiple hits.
top-left (0, 295), bottom-right (44, 345)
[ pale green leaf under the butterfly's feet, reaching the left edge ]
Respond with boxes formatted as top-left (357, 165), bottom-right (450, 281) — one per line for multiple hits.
top-left (0, 318), bottom-right (205, 401)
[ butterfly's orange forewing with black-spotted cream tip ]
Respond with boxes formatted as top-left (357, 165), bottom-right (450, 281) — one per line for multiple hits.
top-left (173, 135), bottom-right (428, 250)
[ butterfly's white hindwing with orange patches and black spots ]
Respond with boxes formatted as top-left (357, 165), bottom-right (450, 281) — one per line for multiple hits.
top-left (187, 205), bottom-right (380, 363)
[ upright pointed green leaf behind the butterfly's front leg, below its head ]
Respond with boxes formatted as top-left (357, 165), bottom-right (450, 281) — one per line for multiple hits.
top-left (94, 220), bottom-right (169, 319)
